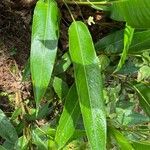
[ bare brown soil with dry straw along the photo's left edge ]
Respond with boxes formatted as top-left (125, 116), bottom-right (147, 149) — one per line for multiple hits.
top-left (0, 0), bottom-right (33, 112)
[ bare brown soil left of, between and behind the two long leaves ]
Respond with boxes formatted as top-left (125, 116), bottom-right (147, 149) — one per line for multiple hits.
top-left (0, 0), bottom-right (121, 108)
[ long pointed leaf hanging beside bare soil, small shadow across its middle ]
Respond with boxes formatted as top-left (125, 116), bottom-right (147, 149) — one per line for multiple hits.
top-left (30, 0), bottom-right (59, 106)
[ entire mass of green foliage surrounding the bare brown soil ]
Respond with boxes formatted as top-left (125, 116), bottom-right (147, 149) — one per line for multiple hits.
top-left (0, 0), bottom-right (150, 150)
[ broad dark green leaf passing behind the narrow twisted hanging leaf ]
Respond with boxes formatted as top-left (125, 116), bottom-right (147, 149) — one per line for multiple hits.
top-left (95, 30), bottom-right (150, 54)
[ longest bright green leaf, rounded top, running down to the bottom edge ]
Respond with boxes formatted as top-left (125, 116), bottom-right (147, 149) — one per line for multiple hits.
top-left (69, 21), bottom-right (106, 150)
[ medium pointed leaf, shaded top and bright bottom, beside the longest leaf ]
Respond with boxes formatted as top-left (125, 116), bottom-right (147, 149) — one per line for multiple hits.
top-left (55, 85), bottom-right (80, 149)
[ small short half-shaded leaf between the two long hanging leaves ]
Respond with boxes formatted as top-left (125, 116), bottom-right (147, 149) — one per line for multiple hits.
top-left (53, 77), bottom-right (69, 100)
